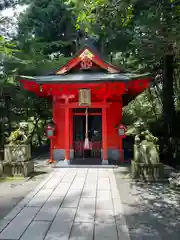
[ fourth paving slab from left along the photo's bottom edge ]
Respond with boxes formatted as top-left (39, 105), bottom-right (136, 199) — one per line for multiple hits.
top-left (70, 223), bottom-right (94, 240)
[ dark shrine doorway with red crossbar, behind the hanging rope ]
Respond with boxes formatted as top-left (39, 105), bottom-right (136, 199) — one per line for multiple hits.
top-left (73, 108), bottom-right (102, 164)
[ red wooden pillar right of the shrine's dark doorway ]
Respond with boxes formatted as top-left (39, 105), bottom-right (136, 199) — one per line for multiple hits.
top-left (102, 106), bottom-right (108, 164)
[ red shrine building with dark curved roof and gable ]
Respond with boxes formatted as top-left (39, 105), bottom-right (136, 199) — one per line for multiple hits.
top-left (20, 40), bottom-right (152, 164)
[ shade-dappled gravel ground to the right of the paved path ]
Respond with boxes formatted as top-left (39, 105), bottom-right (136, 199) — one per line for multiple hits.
top-left (115, 169), bottom-right (180, 240)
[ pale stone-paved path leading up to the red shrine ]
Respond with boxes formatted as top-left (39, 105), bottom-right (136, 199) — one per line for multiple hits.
top-left (0, 168), bottom-right (130, 240)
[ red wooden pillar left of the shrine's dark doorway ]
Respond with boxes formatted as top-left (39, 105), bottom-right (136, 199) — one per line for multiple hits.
top-left (64, 106), bottom-right (70, 165)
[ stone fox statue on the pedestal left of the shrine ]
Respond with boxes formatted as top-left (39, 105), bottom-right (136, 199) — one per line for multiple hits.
top-left (8, 122), bottom-right (28, 145)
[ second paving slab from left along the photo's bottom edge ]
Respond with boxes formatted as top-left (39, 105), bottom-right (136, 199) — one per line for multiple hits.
top-left (20, 221), bottom-right (50, 240)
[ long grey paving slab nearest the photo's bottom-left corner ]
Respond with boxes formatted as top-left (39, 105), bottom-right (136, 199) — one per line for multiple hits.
top-left (0, 207), bottom-right (39, 240)
